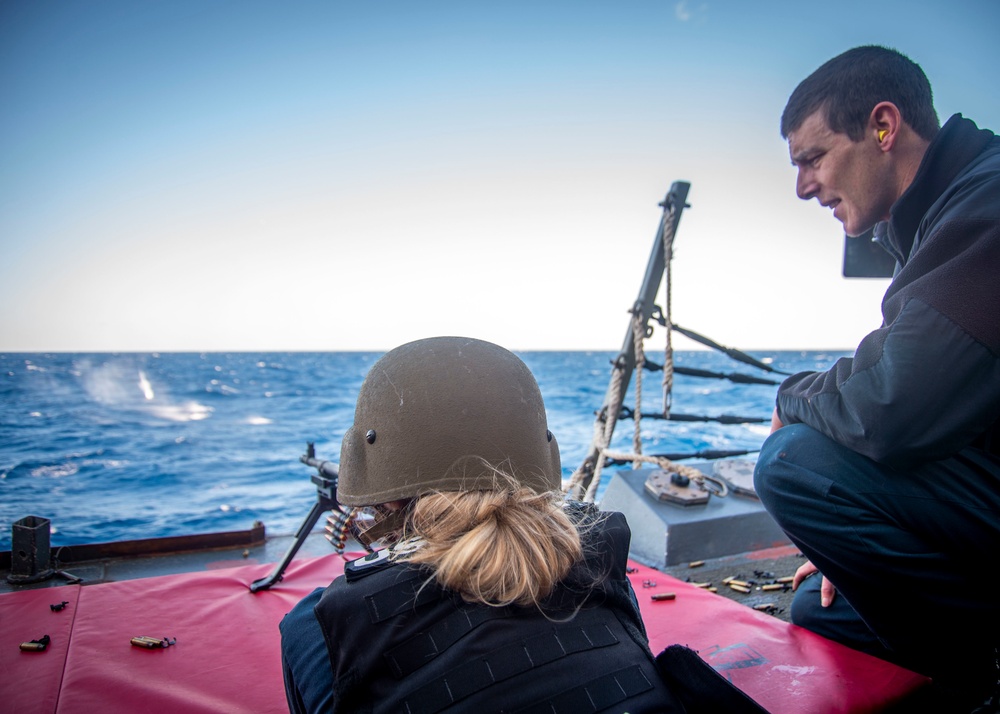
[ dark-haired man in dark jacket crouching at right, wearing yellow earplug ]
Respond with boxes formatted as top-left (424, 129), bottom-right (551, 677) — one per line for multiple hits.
top-left (755, 47), bottom-right (1000, 711)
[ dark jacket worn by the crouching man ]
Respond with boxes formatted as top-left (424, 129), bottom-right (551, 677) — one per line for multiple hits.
top-left (777, 114), bottom-right (1000, 468)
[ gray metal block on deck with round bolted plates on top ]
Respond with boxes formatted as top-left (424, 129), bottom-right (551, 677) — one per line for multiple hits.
top-left (600, 463), bottom-right (791, 567)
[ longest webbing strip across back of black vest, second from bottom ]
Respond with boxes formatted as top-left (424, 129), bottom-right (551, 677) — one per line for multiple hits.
top-left (404, 624), bottom-right (618, 714)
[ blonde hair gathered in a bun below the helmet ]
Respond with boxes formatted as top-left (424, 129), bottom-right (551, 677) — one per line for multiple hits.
top-left (404, 469), bottom-right (583, 606)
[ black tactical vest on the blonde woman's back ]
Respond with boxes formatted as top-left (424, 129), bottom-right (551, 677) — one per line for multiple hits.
top-left (316, 513), bottom-right (684, 714)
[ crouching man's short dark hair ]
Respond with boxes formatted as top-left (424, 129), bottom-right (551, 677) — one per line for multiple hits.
top-left (781, 45), bottom-right (940, 141)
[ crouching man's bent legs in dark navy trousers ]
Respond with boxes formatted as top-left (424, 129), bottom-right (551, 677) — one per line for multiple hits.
top-left (754, 424), bottom-right (1000, 711)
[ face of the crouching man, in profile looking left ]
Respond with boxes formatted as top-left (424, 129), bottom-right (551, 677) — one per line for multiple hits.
top-left (788, 111), bottom-right (895, 236)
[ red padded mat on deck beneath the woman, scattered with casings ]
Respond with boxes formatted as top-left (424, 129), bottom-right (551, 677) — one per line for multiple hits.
top-left (0, 555), bottom-right (925, 714)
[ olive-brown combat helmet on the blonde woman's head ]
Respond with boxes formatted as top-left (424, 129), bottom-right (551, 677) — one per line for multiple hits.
top-left (337, 337), bottom-right (561, 506)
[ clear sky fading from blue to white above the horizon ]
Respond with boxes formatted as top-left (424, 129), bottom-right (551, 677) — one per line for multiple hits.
top-left (0, 0), bottom-right (1000, 351)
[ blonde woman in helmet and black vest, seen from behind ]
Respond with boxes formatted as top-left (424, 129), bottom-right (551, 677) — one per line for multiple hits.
top-left (281, 337), bottom-right (752, 713)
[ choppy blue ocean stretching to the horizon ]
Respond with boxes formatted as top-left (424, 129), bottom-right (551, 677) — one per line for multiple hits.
top-left (0, 351), bottom-right (845, 550)
